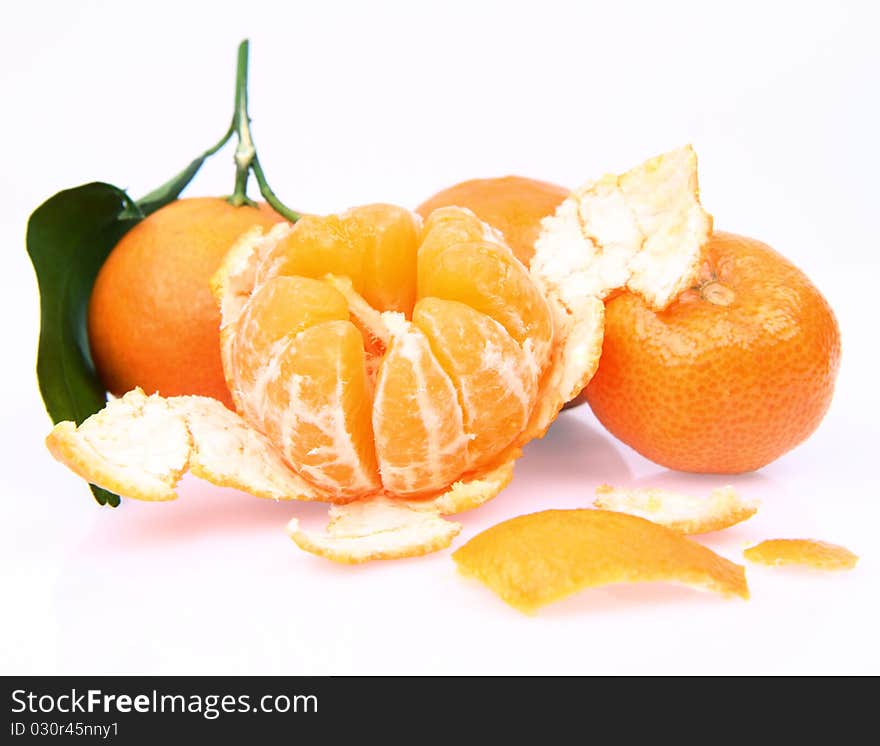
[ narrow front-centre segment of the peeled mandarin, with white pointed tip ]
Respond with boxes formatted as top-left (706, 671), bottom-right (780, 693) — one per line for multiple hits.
top-left (373, 314), bottom-right (468, 494)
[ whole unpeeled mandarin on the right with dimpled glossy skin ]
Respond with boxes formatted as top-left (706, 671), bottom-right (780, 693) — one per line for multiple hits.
top-left (582, 232), bottom-right (840, 474)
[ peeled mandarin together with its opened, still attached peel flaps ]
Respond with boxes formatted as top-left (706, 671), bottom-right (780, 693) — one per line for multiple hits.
top-left (48, 147), bottom-right (711, 561)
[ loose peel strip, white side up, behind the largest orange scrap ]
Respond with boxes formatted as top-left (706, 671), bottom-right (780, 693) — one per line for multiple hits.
top-left (593, 484), bottom-right (758, 534)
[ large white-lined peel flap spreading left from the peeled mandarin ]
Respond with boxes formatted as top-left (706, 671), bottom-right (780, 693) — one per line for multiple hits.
top-left (46, 389), bottom-right (318, 501)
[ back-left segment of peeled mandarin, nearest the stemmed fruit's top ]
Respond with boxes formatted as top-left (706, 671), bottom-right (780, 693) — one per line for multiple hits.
top-left (257, 213), bottom-right (374, 293)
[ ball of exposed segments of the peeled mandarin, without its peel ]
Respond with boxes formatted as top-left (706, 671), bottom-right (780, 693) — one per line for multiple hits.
top-left (224, 205), bottom-right (553, 502)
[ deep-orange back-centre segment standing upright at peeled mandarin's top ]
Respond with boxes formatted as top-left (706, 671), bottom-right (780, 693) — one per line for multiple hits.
top-left (348, 204), bottom-right (421, 317)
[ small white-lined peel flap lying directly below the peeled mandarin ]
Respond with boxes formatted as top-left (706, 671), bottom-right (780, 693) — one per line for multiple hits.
top-left (287, 497), bottom-right (461, 564)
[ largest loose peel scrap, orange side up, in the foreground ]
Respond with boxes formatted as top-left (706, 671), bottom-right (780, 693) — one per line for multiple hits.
top-left (452, 509), bottom-right (749, 613)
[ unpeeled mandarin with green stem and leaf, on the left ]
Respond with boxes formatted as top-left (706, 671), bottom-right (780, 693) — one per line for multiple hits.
top-left (88, 197), bottom-right (282, 404)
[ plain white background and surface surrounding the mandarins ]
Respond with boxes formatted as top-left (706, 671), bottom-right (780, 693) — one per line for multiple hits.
top-left (0, 0), bottom-right (880, 674)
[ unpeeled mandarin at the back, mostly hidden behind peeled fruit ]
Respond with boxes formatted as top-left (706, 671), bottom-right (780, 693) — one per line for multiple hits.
top-left (416, 176), bottom-right (569, 265)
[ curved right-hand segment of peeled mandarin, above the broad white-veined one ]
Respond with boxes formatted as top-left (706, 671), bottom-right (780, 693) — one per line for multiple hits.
top-left (418, 241), bottom-right (553, 367)
